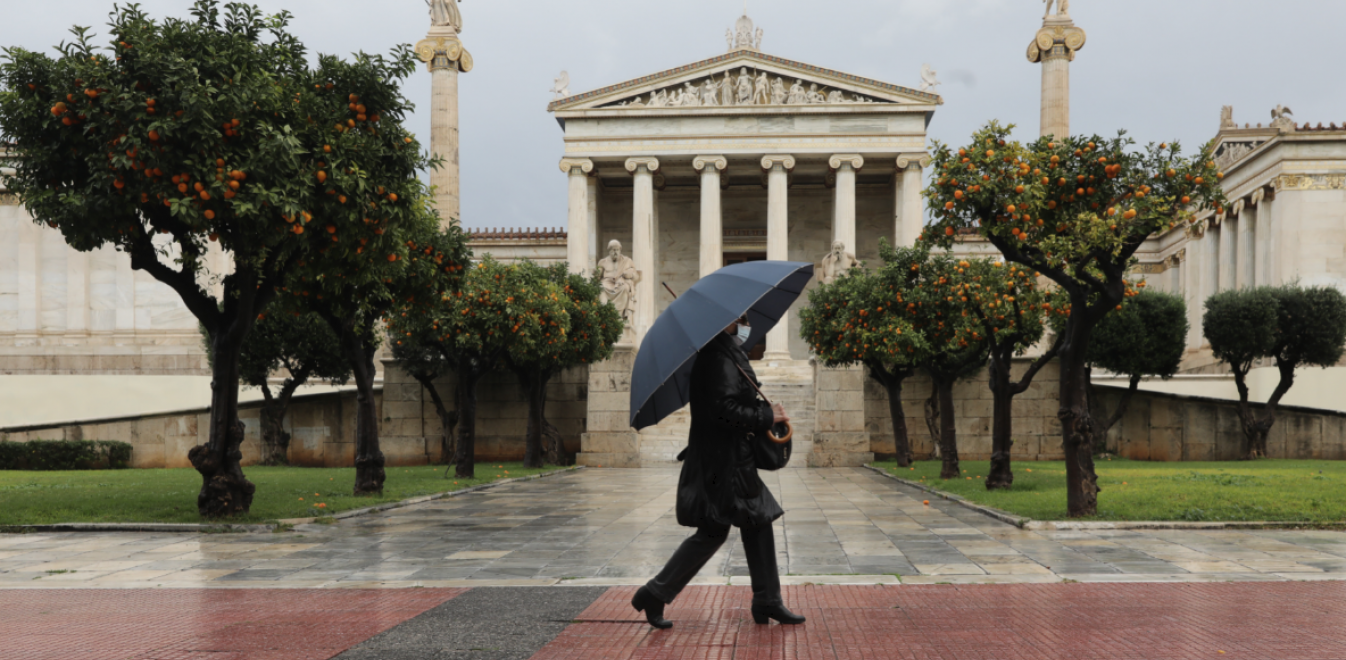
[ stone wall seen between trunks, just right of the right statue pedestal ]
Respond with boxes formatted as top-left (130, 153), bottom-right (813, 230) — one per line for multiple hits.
top-left (866, 360), bottom-right (1065, 461)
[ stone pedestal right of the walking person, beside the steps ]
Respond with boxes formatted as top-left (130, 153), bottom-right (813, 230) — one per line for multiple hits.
top-left (809, 365), bottom-right (874, 467)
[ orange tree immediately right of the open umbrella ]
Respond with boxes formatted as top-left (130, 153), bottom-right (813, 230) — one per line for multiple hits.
top-left (800, 254), bottom-right (929, 467)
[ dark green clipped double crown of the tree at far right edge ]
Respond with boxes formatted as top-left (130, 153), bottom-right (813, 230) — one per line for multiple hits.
top-left (1202, 284), bottom-right (1346, 373)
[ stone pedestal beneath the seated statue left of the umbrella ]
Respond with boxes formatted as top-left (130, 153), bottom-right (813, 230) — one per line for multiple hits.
top-left (576, 343), bottom-right (641, 467)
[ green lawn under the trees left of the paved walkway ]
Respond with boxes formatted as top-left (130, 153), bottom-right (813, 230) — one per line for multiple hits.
top-left (0, 463), bottom-right (556, 525)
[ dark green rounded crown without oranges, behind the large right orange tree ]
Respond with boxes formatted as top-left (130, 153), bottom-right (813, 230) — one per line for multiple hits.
top-left (1082, 291), bottom-right (1189, 378)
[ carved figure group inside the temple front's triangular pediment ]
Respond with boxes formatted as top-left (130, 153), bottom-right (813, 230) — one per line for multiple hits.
top-left (606, 67), bottom-right (888, 108)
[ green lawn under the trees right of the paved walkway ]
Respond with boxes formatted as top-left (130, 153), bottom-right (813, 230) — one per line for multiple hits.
top-left (876, 458), bottom-right (1346, 524)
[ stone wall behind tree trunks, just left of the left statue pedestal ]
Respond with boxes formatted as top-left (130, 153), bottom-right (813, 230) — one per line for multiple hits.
top-left (380, 360), bottom-right (588, 465)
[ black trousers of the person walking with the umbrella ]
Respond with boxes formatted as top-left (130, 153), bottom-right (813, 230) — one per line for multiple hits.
top-left (645, 525), bottom-right (781, 605)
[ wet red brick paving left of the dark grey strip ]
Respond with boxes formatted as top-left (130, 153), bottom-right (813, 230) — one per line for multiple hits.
top-left (0, 589), bottom-right (467, 660)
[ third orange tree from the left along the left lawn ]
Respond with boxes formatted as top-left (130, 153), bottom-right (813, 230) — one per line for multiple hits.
top-left (389, 256), bottom-right (569, 478)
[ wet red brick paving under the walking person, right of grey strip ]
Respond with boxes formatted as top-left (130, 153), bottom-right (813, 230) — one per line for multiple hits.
top-left (533, 582), bottom-right (1346, 660)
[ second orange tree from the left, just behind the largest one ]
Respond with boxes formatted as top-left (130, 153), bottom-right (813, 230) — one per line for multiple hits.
top-left (287, 208), bottom-right (468, 494)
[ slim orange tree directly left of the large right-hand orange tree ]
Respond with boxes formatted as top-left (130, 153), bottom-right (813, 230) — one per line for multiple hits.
top-left (958, 259), bottom-right (1061, 490)
